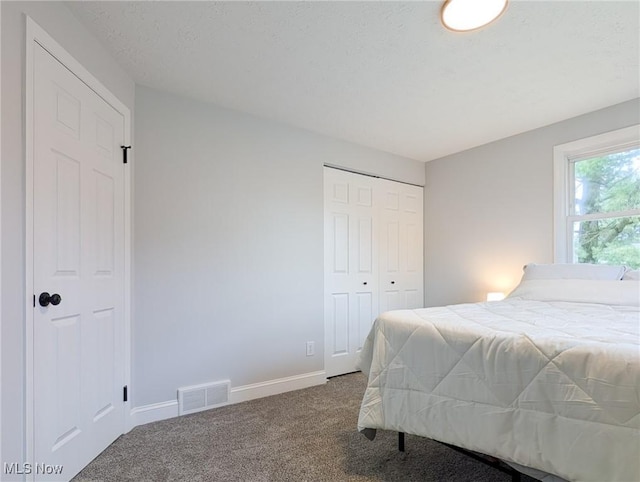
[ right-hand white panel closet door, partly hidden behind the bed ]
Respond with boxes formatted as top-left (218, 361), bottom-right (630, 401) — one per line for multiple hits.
top-left (376, 179), bottom-right (424, 313)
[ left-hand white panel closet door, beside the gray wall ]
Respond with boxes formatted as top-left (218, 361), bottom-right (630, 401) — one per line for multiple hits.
top-left (324, 168), bottom-right (378, 376)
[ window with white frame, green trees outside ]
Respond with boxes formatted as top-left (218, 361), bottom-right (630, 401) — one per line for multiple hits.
top-left (554, 126), bottom-right (640, 268)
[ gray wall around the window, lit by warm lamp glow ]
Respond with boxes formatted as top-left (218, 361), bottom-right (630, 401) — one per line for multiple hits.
top-left (425, 99), bottom-right (640, 306)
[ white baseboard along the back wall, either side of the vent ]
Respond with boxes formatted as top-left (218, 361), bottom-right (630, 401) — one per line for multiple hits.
top-left (129, 371), bottom-right (327, 429)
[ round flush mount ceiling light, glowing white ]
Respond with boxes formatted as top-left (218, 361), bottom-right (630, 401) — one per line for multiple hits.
top-left (440, 0), bottom-right (507, 32)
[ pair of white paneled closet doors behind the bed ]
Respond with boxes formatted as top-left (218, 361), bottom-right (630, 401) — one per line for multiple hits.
top-left (324, 168), bottom-right (423, 376)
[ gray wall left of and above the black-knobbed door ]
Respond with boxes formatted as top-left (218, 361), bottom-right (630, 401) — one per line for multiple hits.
top-left (0, 1), bottom-right (135, 468)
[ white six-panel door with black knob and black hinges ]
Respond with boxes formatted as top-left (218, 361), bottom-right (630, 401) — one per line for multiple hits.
top-left (33, 44), bottom-right (124, 480)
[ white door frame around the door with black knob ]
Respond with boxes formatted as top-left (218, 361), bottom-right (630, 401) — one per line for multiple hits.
top-left (25, 17), bottom-right (133, 470)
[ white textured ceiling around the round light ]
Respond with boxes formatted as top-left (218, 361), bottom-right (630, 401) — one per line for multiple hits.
top-left (67, 0), bottom-right (640, 161)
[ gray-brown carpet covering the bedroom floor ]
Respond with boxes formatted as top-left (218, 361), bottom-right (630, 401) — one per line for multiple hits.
top-left (74, 373), bottom-right (533, 482)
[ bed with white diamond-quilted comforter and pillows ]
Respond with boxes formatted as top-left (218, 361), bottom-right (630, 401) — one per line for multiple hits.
top-left (358, 265), bottom-right (640, 482)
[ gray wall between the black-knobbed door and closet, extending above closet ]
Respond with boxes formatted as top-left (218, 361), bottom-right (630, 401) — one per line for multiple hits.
top-left (133, 87), bottom-right (424, 406)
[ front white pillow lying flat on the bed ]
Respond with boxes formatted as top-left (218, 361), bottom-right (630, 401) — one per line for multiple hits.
top-left (508, 279), bottom-right (640, 306)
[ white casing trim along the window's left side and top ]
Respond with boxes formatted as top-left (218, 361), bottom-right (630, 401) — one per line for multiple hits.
top-left (553, 124), bottom-right (640, 263)
